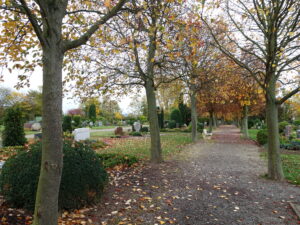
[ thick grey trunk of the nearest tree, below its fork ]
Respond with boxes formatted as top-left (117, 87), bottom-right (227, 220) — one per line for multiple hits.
top-left (33, 45), bottom-right (63, 225)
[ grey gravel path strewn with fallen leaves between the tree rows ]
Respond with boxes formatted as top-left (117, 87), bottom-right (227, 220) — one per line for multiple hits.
top-left (94, 126), bottom-right (300, 225)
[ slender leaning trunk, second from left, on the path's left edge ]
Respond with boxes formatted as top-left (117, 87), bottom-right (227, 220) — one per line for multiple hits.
top-left (145, 81), bottom-right (163, 163)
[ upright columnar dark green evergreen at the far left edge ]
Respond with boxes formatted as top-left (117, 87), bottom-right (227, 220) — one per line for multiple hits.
top-left (2, 107), bottom-right (26, 147)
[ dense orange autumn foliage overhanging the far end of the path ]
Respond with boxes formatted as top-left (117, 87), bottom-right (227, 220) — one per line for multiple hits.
top-left (198, 58), bottom-right (264, 120)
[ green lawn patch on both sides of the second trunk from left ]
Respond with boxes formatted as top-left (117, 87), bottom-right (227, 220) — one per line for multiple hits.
top-left (98, 133), bottom-right (191, 159)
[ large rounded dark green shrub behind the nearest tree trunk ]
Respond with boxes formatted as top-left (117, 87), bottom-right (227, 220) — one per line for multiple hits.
top-left (0, 141), bottom-right (107, 211)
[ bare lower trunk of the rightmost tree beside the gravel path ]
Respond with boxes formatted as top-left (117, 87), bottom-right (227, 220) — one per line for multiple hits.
top-left (266, 90), bottom-right (284, 180)
